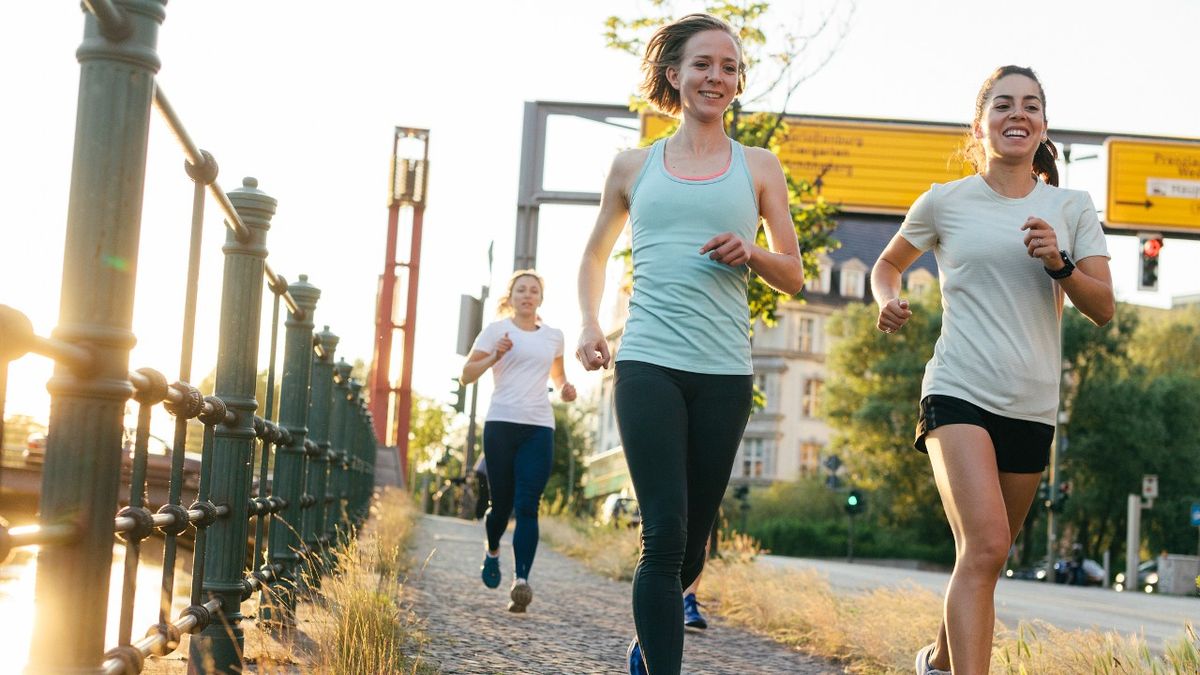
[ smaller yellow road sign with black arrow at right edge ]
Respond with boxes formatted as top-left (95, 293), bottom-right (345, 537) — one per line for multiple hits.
top-left (1104, 138), bottom-right (1200, 232)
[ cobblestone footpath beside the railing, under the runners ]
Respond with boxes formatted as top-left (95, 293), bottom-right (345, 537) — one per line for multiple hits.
top-left (409, 516), bottom-right (841, 675)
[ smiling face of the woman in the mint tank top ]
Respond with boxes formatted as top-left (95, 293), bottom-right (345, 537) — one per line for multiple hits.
top-left (666, 30), bottom-right (742, 121)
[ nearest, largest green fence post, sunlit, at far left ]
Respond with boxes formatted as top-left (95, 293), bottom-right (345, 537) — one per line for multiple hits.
top-left (29, 0), bottom-right (166, 674)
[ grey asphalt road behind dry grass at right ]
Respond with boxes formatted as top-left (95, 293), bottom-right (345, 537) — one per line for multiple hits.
top-left (760, 556), bottom-right (1200, 652)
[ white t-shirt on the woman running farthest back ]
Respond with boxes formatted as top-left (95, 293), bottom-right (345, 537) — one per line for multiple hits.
top-left (472, 318), bottom-right (563, 429)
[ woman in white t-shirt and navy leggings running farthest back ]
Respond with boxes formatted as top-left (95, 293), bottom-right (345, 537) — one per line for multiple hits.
top-left (462, 269), bottom-right (575, 613)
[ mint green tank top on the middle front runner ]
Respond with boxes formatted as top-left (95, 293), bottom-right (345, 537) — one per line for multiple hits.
top-left (617, 139), bottom-right (758, 375)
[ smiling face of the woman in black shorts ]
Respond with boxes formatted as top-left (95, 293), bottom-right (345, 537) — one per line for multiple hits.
top-left (973, 74), bottom-right (1046, 163)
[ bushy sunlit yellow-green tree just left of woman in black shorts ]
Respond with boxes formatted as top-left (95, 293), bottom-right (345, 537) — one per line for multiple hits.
top-left (823, 281), bottom-right (948, 542)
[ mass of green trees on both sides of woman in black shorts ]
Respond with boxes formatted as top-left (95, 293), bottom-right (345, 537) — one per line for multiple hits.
top-left (824, 292), bottom-right (1200, 560)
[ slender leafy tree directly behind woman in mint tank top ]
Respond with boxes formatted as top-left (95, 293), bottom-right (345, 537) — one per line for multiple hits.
top-left (605, 0), bottom-right (854, 325)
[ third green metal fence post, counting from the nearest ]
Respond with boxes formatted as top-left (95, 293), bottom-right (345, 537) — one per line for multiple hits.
top-left (259, 275), bottom-right (320, 627)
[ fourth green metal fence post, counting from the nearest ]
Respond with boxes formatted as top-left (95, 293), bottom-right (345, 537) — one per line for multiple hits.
top-left (302, 325), bottom-right (338, 578)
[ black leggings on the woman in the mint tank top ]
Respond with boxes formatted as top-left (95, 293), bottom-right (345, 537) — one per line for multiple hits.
top-left (613, 362), bottom-right (752, 675)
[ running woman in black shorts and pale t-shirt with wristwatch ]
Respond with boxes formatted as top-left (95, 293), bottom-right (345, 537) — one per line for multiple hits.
top-left (871, 66), bottom-right (1115, 675)
